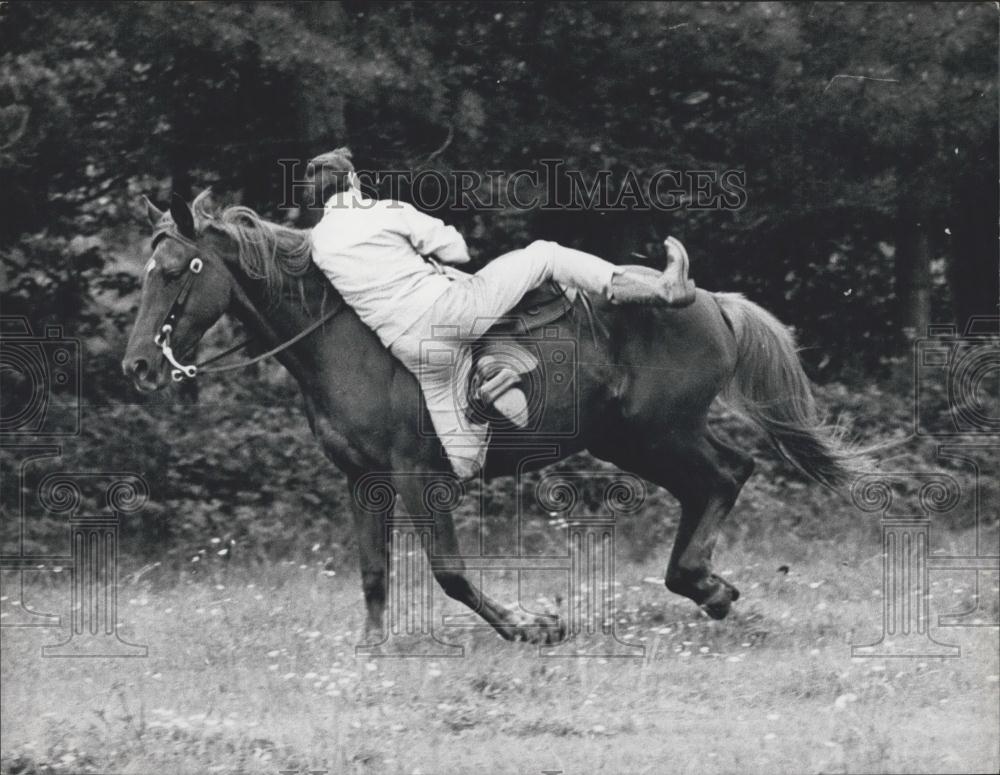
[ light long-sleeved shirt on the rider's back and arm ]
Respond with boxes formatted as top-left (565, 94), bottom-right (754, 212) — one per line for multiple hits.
top-left (312, 190), bottom-right (469, 347)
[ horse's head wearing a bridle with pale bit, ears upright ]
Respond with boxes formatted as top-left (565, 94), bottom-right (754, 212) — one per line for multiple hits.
top-left (122, 192), bottom-right (235, 392)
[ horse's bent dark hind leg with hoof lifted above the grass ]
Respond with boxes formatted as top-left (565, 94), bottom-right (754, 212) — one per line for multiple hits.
top-left (608, 427), bottom-right (754, 619)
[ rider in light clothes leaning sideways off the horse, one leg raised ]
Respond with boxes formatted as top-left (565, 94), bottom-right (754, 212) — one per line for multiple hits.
top-left (309, 148), bottom-right (694, 479)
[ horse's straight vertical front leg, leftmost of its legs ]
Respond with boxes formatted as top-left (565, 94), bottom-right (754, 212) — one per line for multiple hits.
top-left (348, 476), bottom-right (395, 644)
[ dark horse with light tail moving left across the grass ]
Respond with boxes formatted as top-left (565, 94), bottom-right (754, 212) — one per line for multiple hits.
top-left (122, 191), bottom-right (861, 643)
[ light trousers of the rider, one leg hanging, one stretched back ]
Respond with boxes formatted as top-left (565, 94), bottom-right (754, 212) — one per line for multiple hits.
top-left (390, 241), bottom-right (616, 479)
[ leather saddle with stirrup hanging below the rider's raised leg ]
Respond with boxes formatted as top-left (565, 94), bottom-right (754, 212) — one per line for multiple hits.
top-left (467, 281), bottom-right (590, 424)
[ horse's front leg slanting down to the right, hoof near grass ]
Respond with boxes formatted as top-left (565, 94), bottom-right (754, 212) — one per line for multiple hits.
top-left (396, 472), bottom-right (566, 643)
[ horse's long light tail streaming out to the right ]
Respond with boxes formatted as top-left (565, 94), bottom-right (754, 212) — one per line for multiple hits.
top-left (715, 293), bottom-right (867, 489)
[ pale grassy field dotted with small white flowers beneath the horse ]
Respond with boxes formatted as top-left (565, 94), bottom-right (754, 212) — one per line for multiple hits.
top-left (0, 516), bottom-right (1000, 775)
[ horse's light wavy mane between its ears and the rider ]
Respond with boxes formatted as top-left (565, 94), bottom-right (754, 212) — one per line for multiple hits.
top-left (191, 190), bottom-right (313, 301)
